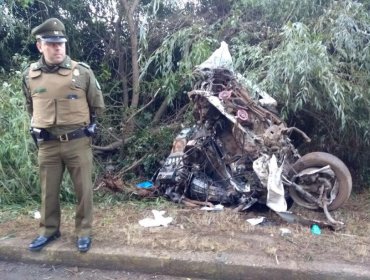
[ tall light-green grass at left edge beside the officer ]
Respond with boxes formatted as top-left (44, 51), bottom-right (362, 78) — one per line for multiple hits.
top-left (0, 62), bottom-right (39, 204)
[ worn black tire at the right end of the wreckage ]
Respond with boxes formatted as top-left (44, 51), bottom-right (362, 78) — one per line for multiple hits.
top-left (289, 152), bottom-right (352, 210)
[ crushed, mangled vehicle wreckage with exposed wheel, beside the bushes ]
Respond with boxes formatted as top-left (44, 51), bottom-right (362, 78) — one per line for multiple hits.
top-left (149, 41), bottom-right (352, 229)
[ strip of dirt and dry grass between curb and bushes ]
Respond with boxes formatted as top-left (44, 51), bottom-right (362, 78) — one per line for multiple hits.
top-left (0, 189), bottom-right (370, 264)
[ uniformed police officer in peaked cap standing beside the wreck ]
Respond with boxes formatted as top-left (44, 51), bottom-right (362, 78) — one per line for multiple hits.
top-left (23, 18), bottom-right (104, 252)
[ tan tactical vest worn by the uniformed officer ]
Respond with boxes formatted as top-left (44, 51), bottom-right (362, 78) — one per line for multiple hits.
top-left (29, 61), bottom-right (90, 128)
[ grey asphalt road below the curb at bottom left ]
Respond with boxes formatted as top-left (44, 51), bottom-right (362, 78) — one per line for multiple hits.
top-left (0, 261), bottom-right (202, 280)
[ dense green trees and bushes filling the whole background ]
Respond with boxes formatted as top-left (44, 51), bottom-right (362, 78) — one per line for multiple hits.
top-left (0, 0), bottom-right (370, 203)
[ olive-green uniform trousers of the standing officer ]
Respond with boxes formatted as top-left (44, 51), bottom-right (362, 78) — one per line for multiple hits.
top-left (38, 137), bottom-right (93, 237)
